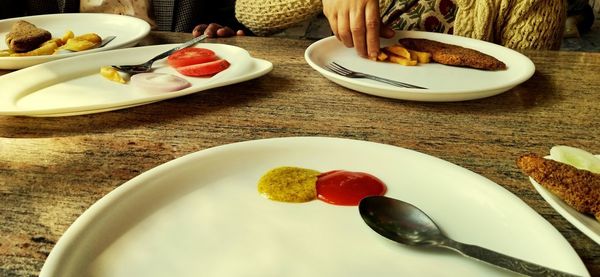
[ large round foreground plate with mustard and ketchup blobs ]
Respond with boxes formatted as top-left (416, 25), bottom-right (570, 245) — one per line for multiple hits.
top-left (41, 137), bottom-right (589, 276)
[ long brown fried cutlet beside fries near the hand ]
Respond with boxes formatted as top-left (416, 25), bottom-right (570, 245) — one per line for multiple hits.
top-left (398, 38), bottom-right (506, 70)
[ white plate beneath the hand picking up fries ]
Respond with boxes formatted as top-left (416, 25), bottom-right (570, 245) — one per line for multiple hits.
top-left (304, 31), bottom-right (535, 102)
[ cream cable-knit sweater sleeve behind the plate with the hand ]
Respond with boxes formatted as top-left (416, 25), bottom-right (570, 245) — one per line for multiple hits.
top-left (454, 0), bottom-right (566, 49)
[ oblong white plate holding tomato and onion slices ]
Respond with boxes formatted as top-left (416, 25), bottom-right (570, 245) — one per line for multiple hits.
top-left (0, 43), bottom-right (272, 116)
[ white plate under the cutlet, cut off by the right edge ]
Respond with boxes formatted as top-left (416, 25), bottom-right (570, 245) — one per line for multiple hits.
top-left (529, 155), bottom-right (600, 244)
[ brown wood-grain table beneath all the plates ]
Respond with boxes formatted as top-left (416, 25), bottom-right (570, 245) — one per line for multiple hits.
top-left (0, 33), bottom-right (600, 276)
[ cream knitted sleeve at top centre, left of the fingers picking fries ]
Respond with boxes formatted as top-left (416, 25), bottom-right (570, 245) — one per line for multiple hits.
top-left (235, 0), bottom-right (322, 35)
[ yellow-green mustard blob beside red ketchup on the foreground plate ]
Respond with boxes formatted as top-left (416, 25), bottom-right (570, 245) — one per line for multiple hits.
top-left (258, 166), bottom-right (320, 203)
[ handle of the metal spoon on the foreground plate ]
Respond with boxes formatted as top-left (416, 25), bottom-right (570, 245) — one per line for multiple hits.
top-left (443, 238), bottom-right (577, 277)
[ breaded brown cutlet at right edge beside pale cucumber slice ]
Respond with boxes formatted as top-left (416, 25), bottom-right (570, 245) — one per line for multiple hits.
top-left (517, 154), bottom-right (600, 221)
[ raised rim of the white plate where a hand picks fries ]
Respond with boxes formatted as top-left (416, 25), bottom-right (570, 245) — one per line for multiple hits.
top-left (304, 31), bottom-right (535, 102)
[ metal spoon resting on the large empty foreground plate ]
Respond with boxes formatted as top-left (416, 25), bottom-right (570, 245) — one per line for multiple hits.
top-left (358, 196), bottom-right (576, 276)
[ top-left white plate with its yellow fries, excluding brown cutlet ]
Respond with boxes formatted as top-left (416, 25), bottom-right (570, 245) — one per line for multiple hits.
top-left (0, 13), bottom-right (150, 69)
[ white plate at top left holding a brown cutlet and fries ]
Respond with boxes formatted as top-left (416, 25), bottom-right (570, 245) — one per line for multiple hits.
top-left (0, 13), bottom-right (150, 69)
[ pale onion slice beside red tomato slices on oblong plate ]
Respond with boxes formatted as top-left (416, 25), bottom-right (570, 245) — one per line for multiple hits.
top-left (130, 73), bottom-right (192, 92)
